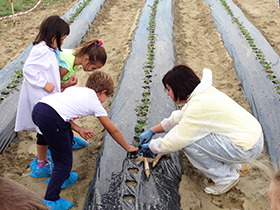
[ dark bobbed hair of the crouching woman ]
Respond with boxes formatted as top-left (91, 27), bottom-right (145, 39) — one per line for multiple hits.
top-left (162, 65), bottom-right (200, 101)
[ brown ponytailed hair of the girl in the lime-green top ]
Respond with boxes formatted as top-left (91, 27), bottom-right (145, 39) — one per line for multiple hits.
top-left (74, 39), bottom-right (107, 65)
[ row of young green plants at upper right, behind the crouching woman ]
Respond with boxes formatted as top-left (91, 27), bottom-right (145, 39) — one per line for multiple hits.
top-left (220, 0), bottom-right (280, 100)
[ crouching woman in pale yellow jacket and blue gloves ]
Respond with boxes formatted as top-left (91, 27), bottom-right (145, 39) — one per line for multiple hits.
top-left (140, 65), bottom-right (263, 195)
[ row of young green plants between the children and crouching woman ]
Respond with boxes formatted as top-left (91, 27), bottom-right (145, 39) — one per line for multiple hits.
top-left (134, 0), bottom-right (159, 142)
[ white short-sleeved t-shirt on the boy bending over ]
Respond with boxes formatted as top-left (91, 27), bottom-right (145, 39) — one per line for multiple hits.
top-left (39, 87), bottom-right (108, 122)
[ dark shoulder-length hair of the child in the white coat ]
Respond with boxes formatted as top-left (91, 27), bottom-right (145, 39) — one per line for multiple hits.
top-left (33, 15), bottom-right (70, 51)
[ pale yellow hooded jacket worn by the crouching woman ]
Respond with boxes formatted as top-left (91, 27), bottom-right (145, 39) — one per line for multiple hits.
top-left (149, 69), bottom-right (262, 154)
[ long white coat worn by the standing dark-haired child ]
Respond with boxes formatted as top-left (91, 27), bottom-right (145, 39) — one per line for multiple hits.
top-left (15, 41), bottom-right (61, 132)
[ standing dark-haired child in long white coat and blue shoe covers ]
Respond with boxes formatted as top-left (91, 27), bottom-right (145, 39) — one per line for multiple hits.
top-left (15, 15), bottom-right (70, 177)
